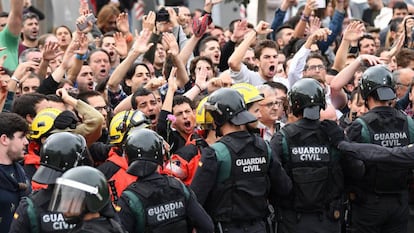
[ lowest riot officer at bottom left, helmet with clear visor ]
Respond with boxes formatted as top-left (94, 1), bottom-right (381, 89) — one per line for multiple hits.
top-left (49, 166), bottom-right (124, 233)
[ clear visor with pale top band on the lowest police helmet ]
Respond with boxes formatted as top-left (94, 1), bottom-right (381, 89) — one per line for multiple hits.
top-left (49, 178), bottom-right (100, 217)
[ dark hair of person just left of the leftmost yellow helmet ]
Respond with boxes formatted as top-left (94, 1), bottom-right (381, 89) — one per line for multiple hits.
top-left (12, 93), bottom-right (47, 119)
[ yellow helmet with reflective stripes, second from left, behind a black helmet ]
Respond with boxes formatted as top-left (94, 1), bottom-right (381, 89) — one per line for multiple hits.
top-left (109, 110), bottom-right (151, 144)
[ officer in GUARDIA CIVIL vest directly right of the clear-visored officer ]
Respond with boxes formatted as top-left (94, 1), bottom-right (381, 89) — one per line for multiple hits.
top-left (119, 129), bottom-right (213, 233)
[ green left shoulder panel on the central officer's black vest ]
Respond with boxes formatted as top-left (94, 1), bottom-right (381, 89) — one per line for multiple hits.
top-left (210, 142), bottom-right (231, 182)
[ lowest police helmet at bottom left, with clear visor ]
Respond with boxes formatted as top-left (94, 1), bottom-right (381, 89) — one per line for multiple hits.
top-left (49, 166), bottom-right (110, 216)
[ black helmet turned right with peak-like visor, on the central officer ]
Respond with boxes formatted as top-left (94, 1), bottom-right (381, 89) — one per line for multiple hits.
top-left (204, 88), bottom-right (257, 127)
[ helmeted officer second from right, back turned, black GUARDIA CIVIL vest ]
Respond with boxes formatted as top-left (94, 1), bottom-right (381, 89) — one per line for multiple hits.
top-left (270, 78), bottom-right (343, 233)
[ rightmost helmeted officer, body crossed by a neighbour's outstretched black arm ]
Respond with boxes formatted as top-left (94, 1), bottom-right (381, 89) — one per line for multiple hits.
top-left (347, 65), bottom-right (414, 233)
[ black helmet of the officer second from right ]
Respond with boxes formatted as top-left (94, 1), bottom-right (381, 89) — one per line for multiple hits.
top-left (288, 78), bottom-right (326, 120)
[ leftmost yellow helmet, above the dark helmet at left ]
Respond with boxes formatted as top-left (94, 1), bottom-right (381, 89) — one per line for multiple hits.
top-left (29, 108), bottom-right (62, 140)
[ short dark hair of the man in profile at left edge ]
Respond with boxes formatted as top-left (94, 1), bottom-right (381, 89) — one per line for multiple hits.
top-left (0, 112), bottom-right (28, 138)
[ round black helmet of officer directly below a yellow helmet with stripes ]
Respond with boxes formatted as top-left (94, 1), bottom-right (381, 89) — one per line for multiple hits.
top-left (124, 129), bottom-right (164, 177)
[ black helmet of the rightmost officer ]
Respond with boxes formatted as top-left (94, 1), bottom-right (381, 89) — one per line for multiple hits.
top-left (359, 65), bottom-right (396, 101)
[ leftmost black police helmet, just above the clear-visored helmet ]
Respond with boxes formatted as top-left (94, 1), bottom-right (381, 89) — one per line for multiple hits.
top-left (32, 132), bottom-right (88, 184)
